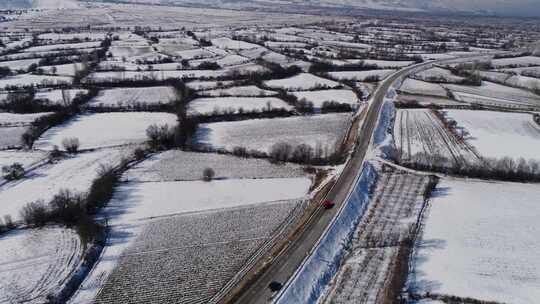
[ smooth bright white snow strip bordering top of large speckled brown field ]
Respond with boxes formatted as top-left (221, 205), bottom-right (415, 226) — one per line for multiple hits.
top-left (107, 177), bottom-right (311, 220)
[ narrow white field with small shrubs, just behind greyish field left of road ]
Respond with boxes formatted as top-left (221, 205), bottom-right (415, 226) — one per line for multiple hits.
top-left (188, 97), bottom-right (294, 116)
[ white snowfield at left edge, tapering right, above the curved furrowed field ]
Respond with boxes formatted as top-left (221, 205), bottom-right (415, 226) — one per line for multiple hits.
top-left (0, 148), bottom-right (131, 220)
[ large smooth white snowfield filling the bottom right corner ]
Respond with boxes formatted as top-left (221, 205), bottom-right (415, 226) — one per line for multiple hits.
top-left (409, 178), bottom-right (540, 304)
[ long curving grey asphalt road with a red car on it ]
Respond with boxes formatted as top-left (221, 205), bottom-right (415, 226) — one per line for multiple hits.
top-left (231, 58), bottom-right (490, 304)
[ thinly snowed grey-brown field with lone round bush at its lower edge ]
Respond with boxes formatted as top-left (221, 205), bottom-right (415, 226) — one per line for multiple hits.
top-left (124, 150), bottom-right (306, 182)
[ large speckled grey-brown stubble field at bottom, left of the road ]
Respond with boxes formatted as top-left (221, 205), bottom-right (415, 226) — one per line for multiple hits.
top-left (90, 200), bottom-right (302, 304)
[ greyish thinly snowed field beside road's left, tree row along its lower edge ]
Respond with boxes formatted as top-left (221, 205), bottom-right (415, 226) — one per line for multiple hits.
top-left (196, 114), bottom-right (351, 154)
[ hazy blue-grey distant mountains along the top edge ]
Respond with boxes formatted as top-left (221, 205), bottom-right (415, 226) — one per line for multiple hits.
top-left (0, 0), bottom-right (540, 17)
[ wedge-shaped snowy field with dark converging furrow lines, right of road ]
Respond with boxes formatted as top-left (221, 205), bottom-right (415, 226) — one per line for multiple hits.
top-left (394, 109), bottom-right (480, 167)
